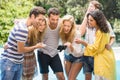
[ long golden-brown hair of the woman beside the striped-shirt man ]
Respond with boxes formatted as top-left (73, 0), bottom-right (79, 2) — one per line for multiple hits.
top-left (27, 19), bottom-right (47, 46)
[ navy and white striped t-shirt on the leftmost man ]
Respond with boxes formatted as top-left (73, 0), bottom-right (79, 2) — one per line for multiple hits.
top-left (2, 21), bottom-right (28, 64)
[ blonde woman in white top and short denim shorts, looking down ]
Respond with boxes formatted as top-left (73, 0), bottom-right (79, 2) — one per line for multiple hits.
top-left (60, 15), bottom-right (83, 80)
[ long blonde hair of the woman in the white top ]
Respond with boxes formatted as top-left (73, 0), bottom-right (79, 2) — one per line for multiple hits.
top-left (59, 15), bottom-right (76, 43)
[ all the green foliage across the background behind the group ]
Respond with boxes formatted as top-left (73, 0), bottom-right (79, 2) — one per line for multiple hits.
top-left (0, 0), bottom-right (120, 44)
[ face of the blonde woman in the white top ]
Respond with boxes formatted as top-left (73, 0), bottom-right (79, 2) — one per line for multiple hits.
top-left (63, 20), bottom-right (72, 34)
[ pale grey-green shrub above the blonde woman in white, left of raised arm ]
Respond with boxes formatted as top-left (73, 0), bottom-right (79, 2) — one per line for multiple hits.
top-left (67, 0), bottom-right (87, 24)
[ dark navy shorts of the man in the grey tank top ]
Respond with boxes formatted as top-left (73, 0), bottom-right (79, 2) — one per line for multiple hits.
top-left (37, 51), bottom-right (63, 74)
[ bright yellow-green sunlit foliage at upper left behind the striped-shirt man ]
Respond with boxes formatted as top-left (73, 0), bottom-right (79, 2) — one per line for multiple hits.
top-left (0, 0), bottom-right (33, 44)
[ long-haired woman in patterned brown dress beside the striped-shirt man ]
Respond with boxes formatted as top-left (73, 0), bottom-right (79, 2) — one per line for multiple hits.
top-left (23, 18), bottom-right (47, 80)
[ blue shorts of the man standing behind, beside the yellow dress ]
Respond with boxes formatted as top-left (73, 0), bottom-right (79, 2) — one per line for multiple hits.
top-left (83, 56), bottom-right (94, 74)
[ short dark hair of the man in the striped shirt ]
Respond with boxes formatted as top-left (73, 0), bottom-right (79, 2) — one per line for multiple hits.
top-left (29, 7), bottom-right (46, 17)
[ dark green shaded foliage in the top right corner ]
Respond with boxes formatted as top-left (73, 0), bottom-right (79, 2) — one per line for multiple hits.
top-left (98, 0), bottom-right (120, 20)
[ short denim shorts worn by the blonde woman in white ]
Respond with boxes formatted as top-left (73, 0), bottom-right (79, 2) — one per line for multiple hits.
top-left (64, 53), bottom-right (84, 63)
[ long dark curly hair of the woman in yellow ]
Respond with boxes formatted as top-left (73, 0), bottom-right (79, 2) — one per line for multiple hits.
top-left (87, 9), bottom-right (109, 33)
